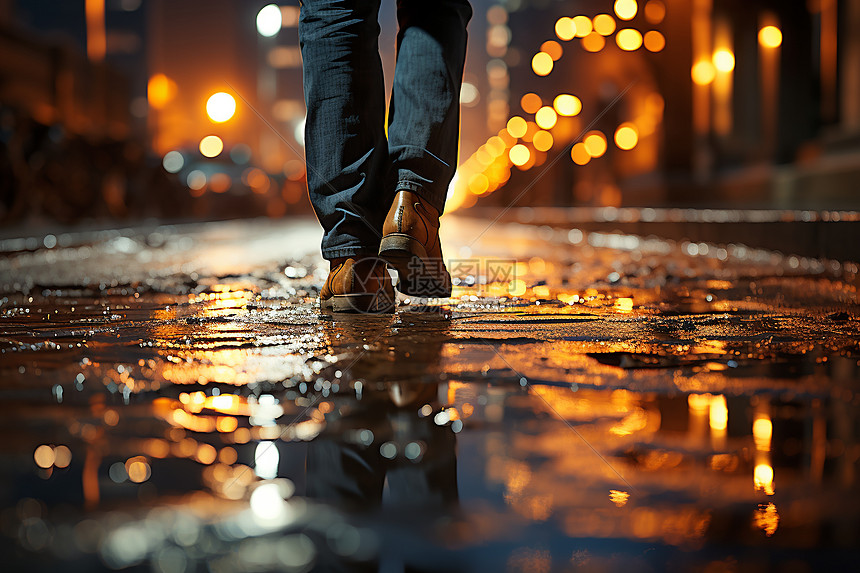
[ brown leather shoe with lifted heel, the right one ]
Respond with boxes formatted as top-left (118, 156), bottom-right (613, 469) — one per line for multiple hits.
top-left (379, 190), bottom-right (451, 297)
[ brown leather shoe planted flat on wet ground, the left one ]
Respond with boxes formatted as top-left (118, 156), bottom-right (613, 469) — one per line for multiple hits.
top-left (320, 257), bottom-right (395, 313)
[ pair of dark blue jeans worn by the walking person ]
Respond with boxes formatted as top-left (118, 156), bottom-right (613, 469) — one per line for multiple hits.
top-left (299, 0), bottom-right (472, 259)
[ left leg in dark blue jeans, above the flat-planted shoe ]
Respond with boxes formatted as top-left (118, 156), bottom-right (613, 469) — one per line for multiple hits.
top-left (299, 0), bottom-right (388, 260)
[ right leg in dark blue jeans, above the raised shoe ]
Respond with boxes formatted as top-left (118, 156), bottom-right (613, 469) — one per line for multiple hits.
top-left (388, 0), bottom-right (472, 213)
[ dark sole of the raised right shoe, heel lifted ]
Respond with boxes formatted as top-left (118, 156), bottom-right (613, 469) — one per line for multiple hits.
top-left (379, 233), bottom-right (451, 298)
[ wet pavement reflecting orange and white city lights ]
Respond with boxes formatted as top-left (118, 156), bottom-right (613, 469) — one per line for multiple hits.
top-left (0, 219), bottom-right (860, 572)
